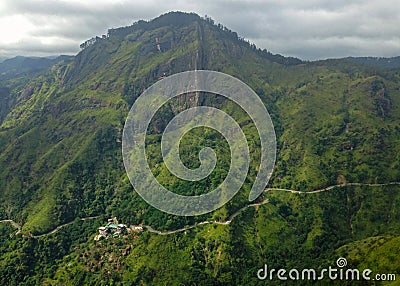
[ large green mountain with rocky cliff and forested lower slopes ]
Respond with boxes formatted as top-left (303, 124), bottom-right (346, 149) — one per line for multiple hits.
top-left (0, 12), bottom-right (400, 285)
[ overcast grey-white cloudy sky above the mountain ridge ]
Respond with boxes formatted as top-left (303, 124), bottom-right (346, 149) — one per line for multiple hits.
top-left (0, 0), bottom-right (400, 60)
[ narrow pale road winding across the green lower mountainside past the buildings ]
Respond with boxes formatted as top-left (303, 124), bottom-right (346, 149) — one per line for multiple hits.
top-left (0, 182), bottom-right (400, 238)
